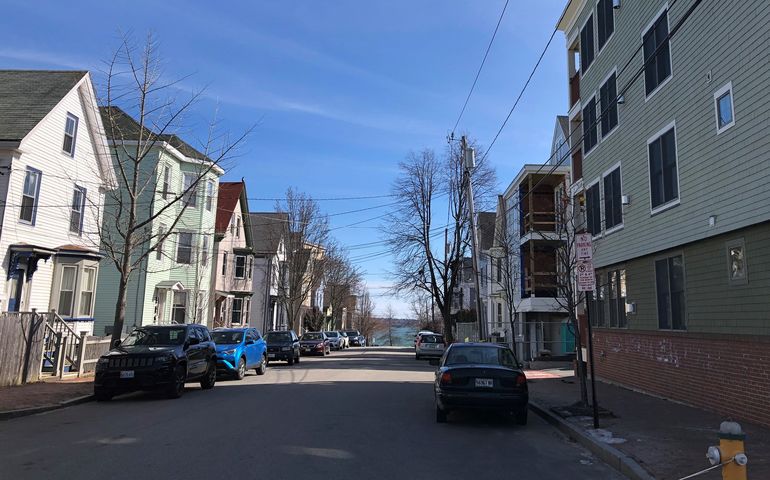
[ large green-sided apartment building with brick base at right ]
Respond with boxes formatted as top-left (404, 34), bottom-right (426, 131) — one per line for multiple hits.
top-left (558, 0), bottom-right (770, 424)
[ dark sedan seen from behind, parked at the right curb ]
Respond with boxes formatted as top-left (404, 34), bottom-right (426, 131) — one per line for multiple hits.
top-left (431, 343), bottom-right (529, 425)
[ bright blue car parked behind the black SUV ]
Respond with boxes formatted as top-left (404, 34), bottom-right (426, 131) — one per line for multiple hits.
top-left (211, 328), bottom-right (268, 380)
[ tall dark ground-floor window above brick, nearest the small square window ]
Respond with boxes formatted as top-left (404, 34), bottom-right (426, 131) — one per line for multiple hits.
top-left (655, 255), bottom-right (686, 330)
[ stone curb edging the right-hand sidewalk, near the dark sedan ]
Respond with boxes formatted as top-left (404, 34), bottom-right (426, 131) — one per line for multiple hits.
top-left (529, 399), bottom-right (655, 480)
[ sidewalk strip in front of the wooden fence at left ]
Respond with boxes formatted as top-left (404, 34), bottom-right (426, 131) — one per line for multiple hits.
top-left (0, 377), bottom-right (94, 420)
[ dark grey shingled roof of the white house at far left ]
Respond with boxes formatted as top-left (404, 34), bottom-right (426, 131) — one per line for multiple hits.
top-left (0, 70), bottom-right (88, 141)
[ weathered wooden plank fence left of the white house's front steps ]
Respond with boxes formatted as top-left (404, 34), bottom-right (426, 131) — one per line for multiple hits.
top-left (0, 312), bottom-right (46, 387)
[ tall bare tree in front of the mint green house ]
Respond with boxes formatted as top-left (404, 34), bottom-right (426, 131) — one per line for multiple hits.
top-left (100, 35), bottom-right (251, 342)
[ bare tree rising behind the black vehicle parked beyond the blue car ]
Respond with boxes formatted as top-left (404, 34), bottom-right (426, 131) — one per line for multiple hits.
top-left (275, 188), bottom-right (329, 330)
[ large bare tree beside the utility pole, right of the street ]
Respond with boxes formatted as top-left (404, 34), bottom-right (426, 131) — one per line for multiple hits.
top-left (383, 142), bottom-right (496, 341)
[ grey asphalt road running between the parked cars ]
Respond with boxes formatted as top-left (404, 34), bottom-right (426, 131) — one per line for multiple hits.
top-left (0, 348), bottom-right (622, 480)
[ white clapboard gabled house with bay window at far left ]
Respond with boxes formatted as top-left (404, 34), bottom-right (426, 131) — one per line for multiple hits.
top-left (0, 70), bottom-right (115, 331)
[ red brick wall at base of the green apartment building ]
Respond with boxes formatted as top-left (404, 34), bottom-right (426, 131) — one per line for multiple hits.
top-left (594, 329), bottom-right (770, 426)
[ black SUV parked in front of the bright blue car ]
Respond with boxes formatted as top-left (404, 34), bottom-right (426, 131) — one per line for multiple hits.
top-left (94, 324), bottom-right (217, 401)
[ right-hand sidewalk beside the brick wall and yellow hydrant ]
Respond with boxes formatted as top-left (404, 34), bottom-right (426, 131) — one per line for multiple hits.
top-left (529, 370), bottom-right (770, 480)
